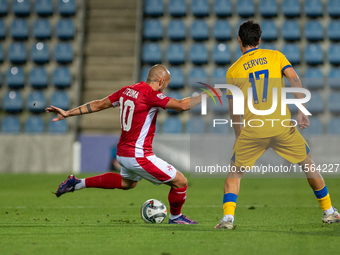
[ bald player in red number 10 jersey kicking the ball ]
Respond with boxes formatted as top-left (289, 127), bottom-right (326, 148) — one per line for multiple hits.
top-left (46, 65), bottom-right (221, 224)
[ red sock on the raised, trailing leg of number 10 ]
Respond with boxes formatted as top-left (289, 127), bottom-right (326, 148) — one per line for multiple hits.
top-left (85, 173), bottom-right (123, 189)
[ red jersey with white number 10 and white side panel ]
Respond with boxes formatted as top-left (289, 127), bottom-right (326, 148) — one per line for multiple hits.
top-left (109, 81), bottom-right (170, 158)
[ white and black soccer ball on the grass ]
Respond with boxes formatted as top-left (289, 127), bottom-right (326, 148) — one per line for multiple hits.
top-left (140, 199), bottom-right (167, 223)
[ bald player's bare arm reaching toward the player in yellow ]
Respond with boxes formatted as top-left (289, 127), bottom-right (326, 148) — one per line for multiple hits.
top-left (165, 88), bottom-right (222, 112)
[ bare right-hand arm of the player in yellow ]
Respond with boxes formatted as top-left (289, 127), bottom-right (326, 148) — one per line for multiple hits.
top-left (283, 68), bottom-right (309, 129)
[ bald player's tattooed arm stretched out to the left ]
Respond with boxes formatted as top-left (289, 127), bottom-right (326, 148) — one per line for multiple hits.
top-left (45, 97), bottom-right (112, 121)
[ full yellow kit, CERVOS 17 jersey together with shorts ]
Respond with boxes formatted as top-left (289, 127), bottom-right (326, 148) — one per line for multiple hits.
top-left (227, 48), bottom-right (310, 167)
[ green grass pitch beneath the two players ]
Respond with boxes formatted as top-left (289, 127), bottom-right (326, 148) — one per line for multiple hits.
top-left (0, 174), bottom-right (340, 255)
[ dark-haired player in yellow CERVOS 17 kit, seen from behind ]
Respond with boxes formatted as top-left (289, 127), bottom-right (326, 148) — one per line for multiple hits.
top-left (215, 20), bottom-right (340, 229)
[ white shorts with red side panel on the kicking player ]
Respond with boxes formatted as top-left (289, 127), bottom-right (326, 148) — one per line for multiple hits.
top-left (117, 155), bottom-right (177, 185)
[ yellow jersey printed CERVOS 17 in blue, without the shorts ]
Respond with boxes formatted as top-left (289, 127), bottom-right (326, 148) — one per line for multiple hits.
top-left (227, 48), bottom-right (292, 138)
